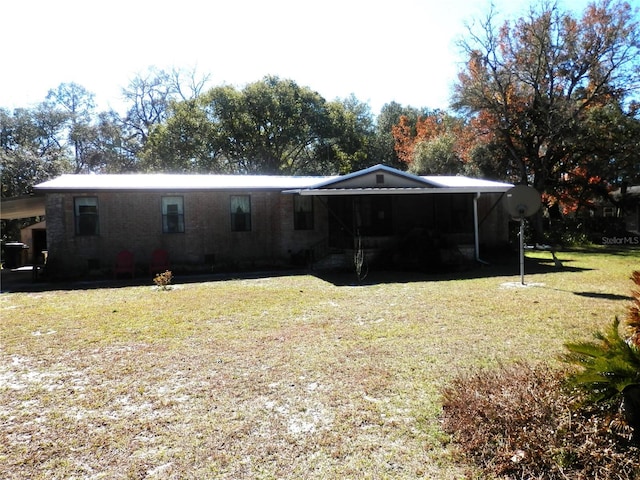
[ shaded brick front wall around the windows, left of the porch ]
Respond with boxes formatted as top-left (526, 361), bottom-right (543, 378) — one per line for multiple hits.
top-left (47, 191), bottom-right (327, 275)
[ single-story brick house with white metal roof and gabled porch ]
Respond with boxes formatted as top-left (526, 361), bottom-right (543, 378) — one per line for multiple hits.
top-left (35, 165), bottom-right (512, 275)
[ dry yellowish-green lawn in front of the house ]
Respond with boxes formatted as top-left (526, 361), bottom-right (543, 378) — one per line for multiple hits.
top-left (0, 251), bottom-right (640, 479)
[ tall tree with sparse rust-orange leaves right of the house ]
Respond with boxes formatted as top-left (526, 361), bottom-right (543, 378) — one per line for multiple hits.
top-left (453, 0), bottom-right (640, 212)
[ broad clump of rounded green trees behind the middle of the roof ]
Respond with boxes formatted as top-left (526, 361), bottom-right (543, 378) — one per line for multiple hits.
top-left (144, 77), bottom-right (360, 175)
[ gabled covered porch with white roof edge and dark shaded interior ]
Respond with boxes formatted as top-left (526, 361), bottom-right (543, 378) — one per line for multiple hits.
top-left (285, 165), bottom-right (513, 270)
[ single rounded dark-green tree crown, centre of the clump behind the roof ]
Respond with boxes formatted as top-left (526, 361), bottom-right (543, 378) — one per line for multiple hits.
top-left (205, 76), bottom-right (338, 174)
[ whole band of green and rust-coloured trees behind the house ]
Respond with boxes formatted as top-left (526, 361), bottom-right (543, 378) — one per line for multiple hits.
top-left (0, 0), bottom-right (640, 227)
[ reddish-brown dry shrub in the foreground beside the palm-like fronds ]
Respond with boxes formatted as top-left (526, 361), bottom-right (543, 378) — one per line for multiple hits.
top-left (442, 364), bottom-right (640, 480)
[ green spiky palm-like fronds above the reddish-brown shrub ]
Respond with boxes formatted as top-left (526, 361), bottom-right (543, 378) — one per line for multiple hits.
top-left (562, 318), bottom-right (640, 402)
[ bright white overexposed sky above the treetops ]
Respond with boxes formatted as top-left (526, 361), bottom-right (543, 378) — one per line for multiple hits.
top-left (0, 0), bottom-right (640, 114)
